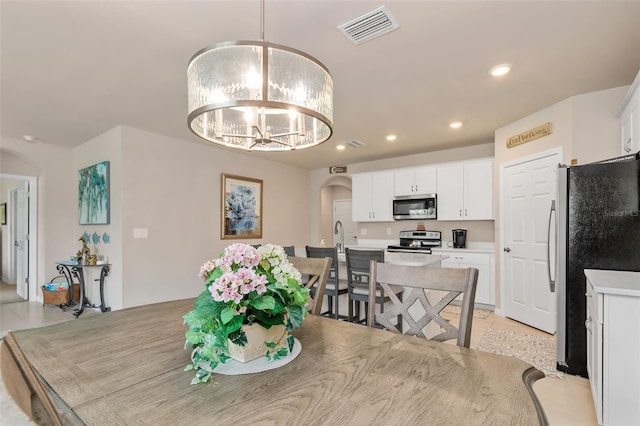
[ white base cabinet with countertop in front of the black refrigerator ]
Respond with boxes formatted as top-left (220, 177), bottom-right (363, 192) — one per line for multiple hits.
top-left (584, 269), bottom-right (640, 425)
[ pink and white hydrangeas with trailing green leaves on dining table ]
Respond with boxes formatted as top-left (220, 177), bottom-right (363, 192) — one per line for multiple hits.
top-left (183, 243), bottom-right (309, 384)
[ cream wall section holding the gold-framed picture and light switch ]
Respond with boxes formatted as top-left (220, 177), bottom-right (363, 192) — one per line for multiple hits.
top-left (121, 127), bottom-right (310, 307)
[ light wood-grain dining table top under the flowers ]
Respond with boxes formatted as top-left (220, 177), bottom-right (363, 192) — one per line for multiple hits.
top-left (2, 299), bottom-right (546, 425)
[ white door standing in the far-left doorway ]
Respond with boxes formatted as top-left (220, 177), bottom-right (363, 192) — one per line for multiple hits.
top-left (15, 181), bottom-right (29, 299)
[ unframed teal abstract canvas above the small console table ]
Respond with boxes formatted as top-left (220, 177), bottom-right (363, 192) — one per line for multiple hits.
top-left (78, 161), bottom-right (109, 225)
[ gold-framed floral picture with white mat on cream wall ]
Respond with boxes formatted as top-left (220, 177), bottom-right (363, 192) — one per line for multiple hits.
top-left (220, 173), bottom-right (262, 240)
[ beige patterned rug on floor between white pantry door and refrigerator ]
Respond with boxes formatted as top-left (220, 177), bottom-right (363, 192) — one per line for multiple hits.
top-left (478, 329), bottom-right (564, 379)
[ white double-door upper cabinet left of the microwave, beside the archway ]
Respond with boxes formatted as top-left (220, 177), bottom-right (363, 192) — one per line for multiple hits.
top-left (351, 171), bottom-right (393, 222)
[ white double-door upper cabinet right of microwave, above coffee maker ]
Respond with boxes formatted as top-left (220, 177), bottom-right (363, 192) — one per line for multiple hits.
top-left (437, 159), bottom-right (493, 220)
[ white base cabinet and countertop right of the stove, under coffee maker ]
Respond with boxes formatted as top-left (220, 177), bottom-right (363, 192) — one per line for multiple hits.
top-left (431, 249), bottom-right (496, 306)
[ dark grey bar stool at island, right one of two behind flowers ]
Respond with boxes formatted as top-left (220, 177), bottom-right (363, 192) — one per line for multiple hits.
top-left (345, 248), bottom-right (402, 323)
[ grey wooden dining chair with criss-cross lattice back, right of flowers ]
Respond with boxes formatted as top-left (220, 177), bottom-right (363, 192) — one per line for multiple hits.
top-left (367, 260), bottom-right (478, 348)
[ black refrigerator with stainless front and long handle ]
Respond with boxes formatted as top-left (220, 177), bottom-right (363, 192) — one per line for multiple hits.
top-left (550, 153), bottom-right (640, 377)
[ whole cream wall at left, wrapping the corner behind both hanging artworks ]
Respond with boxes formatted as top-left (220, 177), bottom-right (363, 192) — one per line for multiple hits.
top-left (0, 127), bottom-right (311, 309)
